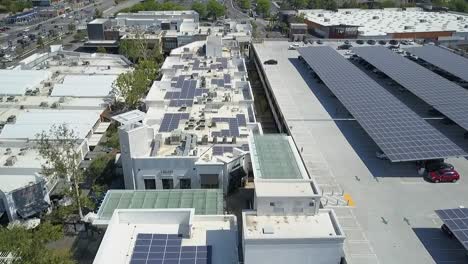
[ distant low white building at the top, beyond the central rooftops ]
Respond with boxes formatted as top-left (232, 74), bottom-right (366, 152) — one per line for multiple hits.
top-left (115, 10), bottom-right (199, 30)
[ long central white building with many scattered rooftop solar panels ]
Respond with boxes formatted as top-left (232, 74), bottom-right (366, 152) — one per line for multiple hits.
top-left (114, 43), bottom-right (261, 191)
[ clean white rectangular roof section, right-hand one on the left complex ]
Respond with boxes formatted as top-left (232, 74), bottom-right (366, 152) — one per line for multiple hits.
top-left (51, 75), bottom-right (117, 97)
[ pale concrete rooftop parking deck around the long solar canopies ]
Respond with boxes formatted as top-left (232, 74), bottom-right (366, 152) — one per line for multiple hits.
top-left (255, 42), bottom-right (468, 263)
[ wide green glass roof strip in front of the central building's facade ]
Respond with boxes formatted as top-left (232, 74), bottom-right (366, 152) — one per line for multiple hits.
top-left (98, 189), bottom-right (224, 220)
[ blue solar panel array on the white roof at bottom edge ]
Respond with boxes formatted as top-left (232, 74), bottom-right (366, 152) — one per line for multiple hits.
top-left (130, 234), bottom-right (212, 264)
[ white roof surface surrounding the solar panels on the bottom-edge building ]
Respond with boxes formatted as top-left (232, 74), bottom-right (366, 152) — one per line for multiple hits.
top-left (93, 209), bottom-right (238, 264)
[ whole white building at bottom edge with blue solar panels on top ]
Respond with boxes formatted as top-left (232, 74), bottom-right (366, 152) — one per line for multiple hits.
top-left (93, 209), bottom-right (239, 264)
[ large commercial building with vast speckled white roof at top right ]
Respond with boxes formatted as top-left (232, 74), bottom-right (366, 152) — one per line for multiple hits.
top-left (299, 8), bottom-right (468, 41)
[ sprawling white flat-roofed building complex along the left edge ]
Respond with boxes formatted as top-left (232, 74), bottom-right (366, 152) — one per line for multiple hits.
top-left (0, 49), bottom-right (129, 222)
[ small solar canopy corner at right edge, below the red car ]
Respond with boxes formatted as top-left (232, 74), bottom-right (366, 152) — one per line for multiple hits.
top-left (435, 208), bottom-right (468, 250)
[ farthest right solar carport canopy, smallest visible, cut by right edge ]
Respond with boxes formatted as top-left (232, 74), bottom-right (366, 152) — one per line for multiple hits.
top-left (405, 45), bottom-right (468, 81)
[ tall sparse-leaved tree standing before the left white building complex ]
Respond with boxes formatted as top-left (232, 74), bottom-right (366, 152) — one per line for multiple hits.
top-left (37, 124), bottom-right (83, 219)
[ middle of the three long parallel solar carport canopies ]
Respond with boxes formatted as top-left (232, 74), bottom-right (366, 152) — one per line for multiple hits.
top-left (353, 47), bottom-right (468, 130)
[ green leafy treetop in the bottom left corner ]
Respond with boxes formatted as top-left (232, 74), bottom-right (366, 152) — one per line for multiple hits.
top-left (0, 222), bottom-right (75, 264)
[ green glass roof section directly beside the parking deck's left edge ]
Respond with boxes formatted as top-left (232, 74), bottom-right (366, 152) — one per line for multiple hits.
top-left (250, 134), bottom-right (303, 179)
